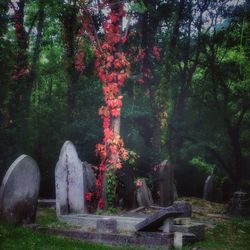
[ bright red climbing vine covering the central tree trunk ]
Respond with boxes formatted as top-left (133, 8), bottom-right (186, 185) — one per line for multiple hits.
top-left (77, 1), bottom-right (130, 209)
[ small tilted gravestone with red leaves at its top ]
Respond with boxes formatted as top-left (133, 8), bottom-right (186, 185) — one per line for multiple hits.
top-left (136, 179), bottom-right (154, 207)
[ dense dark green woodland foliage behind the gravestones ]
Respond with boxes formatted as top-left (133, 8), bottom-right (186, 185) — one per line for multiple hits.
top-left (0, 0), bottom-right (250, 201)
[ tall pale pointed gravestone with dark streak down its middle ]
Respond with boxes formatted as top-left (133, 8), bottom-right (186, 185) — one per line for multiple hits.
top-left (55, 141), bottom-right (86, 215)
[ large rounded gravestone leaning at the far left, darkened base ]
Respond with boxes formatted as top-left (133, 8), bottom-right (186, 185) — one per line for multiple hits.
top-left (0, 155), bottom-right (40, 224)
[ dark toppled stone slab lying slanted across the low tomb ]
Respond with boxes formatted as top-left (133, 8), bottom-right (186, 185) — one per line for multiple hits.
top-left (135, 203), bottom-right (192, 232)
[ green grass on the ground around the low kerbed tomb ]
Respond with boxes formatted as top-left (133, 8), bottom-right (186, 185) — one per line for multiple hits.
top-left (0, 200), bottom-right (250, 250)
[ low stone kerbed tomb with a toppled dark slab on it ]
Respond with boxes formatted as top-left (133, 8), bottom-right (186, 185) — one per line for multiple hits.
top-left (58, 202), bottom-right (204, 247)
